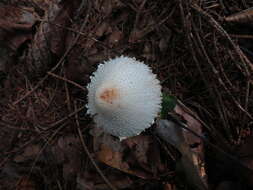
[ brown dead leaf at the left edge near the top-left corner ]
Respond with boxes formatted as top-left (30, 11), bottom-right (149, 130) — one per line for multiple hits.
top-left (0, 5), bottom-right (38, 74)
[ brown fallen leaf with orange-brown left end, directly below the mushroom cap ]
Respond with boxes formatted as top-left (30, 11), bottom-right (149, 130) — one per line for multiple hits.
top-left (96, 135), bottom-right (166, 179)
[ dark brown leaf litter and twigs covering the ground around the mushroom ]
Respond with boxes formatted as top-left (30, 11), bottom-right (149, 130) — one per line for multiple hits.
top-left (0, 0), bottom-right (253, 190)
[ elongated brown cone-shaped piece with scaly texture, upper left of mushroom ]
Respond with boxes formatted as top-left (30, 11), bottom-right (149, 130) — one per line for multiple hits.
top-left (26, 1), bottom-right (79, 74)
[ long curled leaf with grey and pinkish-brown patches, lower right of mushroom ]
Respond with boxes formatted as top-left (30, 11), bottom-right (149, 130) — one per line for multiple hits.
top-left (155, 99), bottom-right (207, 190)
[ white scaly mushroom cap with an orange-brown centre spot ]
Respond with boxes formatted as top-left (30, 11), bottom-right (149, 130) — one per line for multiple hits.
top-left (87, 56), bottom-right (162, 139)
